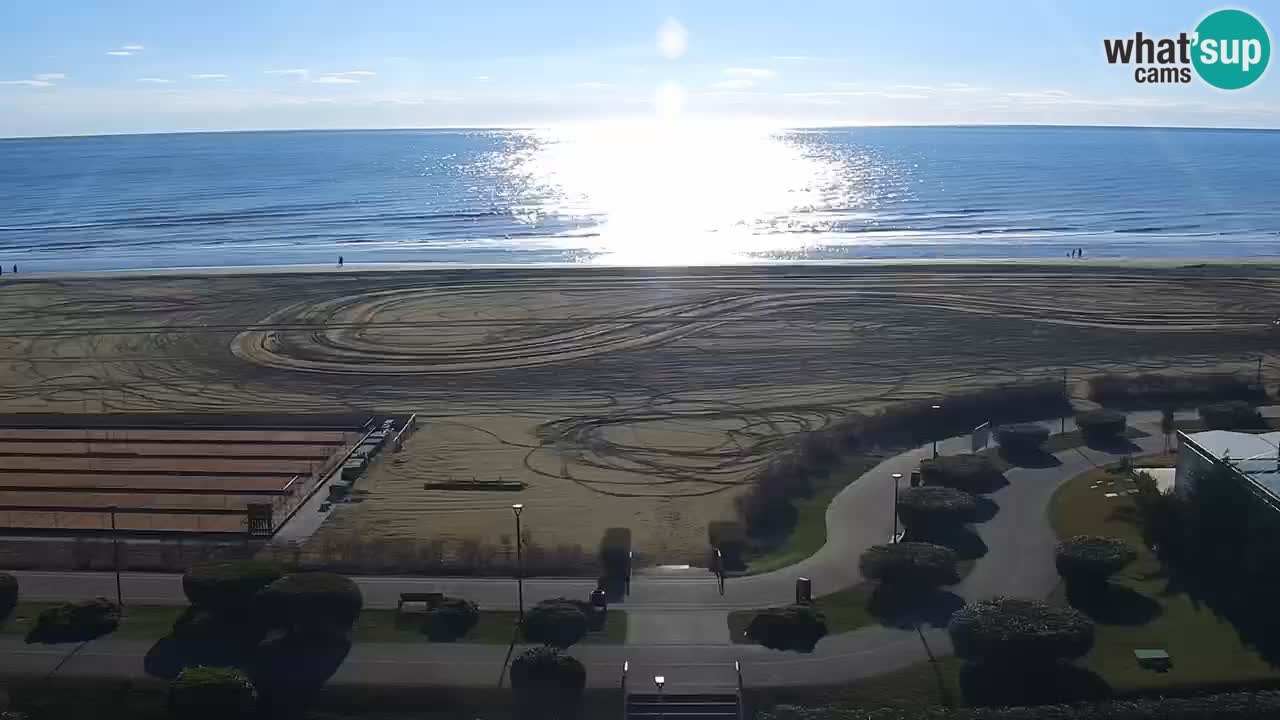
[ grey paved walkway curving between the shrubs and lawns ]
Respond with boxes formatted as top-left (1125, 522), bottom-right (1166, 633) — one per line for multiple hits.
top-left (0, 406), bottom-right (1280, 689)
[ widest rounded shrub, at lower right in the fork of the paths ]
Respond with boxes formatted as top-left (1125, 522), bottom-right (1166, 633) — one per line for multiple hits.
top-left (947, 597), bottom-right (1093, 665)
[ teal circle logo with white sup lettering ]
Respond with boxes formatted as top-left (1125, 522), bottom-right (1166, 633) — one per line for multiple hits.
top-left (1192, 10), bottom-right (1271, 90)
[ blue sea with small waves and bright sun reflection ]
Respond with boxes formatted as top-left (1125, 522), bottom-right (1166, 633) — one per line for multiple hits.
top-left (0, 128), bottom-right (1280, 270)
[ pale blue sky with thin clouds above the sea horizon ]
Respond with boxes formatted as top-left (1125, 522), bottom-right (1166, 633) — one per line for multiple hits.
top-left (0, 0), bottom-right (1280, 136)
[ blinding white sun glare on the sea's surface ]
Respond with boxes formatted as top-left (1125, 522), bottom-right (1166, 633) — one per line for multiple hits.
top-left (513, 117), bottom-right (858, 265)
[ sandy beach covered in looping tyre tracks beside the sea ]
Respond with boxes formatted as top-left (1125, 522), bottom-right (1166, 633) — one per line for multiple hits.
top-left (0, 263), bottom-right (1280, 562)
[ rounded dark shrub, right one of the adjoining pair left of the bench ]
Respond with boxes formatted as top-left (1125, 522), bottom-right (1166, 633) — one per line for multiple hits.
top-left (257, 573), bottom-right (364, 639)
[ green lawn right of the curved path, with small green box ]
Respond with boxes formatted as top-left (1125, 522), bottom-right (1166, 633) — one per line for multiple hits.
top-left (1050, 455), bottom-right (1280, 693)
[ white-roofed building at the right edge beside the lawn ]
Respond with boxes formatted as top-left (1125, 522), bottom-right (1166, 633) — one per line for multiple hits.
top-left (1174, 430), bottom-right (1280, 507)
